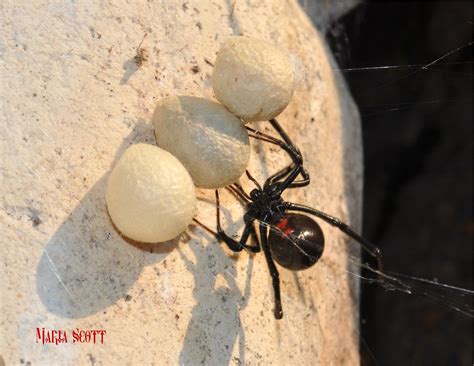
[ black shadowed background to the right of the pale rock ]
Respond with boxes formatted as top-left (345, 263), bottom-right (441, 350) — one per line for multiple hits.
top-left (327, 1), bottom-right (474, 365)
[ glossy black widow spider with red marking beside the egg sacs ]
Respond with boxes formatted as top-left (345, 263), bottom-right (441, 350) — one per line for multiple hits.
top-left (194, 119), bottom-right (382, 319)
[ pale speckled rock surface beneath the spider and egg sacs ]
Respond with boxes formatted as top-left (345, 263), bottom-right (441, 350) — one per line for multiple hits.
top-left (0, 0), bottom-right (362, 365)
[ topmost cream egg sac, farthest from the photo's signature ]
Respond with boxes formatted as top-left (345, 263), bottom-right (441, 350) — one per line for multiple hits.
top-left (212, 36), bottom-right (295, 122)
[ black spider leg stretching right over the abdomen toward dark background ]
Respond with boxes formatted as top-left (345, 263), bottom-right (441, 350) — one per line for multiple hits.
top-left (285, 202), bottom-right (383, 276)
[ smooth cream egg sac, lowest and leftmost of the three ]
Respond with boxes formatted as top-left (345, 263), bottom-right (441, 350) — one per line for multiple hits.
top-left (106, 144), bottom-right (196, 243)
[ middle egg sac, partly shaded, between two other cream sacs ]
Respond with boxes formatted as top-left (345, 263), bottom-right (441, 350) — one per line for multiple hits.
top-left (152, 96), bottom-right (250, 188)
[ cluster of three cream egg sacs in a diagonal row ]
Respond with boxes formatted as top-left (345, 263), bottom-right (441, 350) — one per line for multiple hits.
top-left (106, 37), bottom-right (295, 243)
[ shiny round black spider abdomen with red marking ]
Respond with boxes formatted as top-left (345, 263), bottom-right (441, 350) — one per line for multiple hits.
top-left (268, 214), bottom-right (324, 271)
